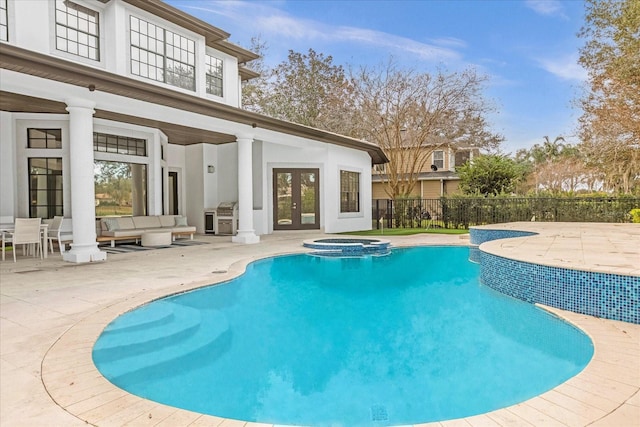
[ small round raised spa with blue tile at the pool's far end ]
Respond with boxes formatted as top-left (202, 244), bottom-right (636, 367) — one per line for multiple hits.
top-left (302, 237), bottom-right (391, 256)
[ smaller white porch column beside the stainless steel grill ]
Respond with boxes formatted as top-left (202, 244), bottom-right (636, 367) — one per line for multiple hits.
top-left (231, 134), bottom-right (260, 247)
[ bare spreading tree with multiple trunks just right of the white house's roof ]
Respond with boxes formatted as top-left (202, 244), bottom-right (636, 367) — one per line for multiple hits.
top-left (350, 60), bottom-right (503, 199)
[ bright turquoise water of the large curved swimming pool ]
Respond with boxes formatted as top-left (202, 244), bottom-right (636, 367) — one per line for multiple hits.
top-left (93, 247), bottom-right (593, 426)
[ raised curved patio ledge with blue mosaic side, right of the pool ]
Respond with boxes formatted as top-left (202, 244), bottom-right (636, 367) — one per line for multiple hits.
top-left (470, 223), bottom-right (640, 324)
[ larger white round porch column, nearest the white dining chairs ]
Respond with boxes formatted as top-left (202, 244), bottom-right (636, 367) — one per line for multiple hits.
top-left (62, 98), bottom-right (107, 262)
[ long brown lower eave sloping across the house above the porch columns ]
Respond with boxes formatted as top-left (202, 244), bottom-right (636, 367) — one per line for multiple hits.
top-left (0, 43), bottom-right (389, 164)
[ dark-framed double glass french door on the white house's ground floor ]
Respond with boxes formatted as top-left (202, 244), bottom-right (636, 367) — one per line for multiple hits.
top-left (273, 169), bottom-right (320, 230)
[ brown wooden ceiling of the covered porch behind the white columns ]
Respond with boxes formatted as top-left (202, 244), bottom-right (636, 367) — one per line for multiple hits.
top-left (0, 91), bottom-right (236, 145)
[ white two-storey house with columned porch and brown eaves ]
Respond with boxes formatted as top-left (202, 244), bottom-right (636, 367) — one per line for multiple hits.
top-left (0, 0), bottom-right (386, 262)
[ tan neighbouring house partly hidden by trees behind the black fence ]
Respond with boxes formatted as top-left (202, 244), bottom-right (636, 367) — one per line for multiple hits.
top-left (371, 144), bottom-right (479, 199)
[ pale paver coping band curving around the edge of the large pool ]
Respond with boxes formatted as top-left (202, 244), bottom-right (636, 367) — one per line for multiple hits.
top-left (41, 236), bottom-right (640, 427)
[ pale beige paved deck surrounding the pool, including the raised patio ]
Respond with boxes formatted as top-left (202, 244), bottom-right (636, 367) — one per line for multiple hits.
top-left (0, 223), bottom-right (640, 427)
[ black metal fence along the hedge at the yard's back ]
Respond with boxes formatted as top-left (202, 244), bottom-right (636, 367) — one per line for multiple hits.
top-left (372, 197), bottom-right (640, 229)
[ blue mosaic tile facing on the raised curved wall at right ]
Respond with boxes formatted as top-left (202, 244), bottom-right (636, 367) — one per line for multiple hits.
top-left (470, 229), bottom-right (640, 324)
